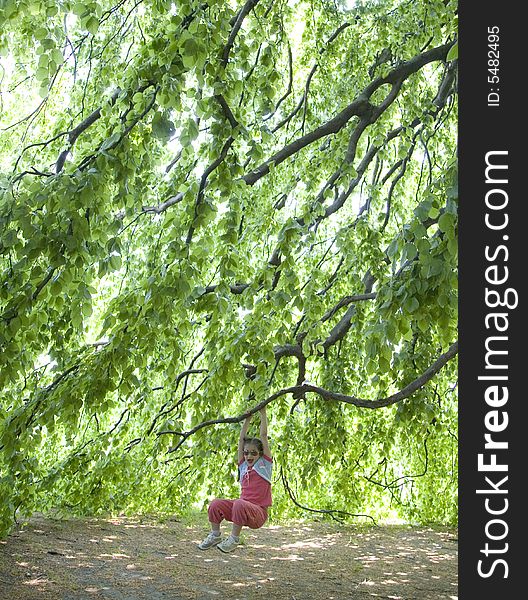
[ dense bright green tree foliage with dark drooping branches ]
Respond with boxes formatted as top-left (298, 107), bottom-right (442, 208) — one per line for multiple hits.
top-left (0, 0), bottom-right (458, 532)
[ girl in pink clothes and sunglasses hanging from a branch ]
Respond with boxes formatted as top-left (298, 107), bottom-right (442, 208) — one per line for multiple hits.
top-left (198, 407), bottom-right (273, 552)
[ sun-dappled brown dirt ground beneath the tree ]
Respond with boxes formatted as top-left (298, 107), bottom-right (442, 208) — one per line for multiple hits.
top-left (0, 517), bottom-right (458, 600)
